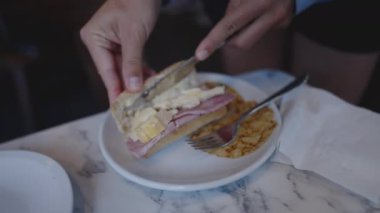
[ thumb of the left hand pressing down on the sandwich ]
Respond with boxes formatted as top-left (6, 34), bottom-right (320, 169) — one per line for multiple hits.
top-left (121, 25), bottom-right (147, 92)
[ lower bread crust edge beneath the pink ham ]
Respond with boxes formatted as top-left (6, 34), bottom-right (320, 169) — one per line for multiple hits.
top-left (144, 107), bottom-right (227, 158)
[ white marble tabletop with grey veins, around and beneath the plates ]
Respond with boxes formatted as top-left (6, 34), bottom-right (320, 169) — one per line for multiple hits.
top-left (0, 72), bottom-right (380, 213)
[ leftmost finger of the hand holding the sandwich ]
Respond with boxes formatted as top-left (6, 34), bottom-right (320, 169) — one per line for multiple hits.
top-left (81, 30), bottom-right (123, 103)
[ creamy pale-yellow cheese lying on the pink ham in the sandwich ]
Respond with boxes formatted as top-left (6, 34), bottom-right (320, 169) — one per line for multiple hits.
top-left (128, 73), bottom-right (224, 143)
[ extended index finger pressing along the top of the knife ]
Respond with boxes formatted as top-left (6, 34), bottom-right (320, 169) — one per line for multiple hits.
top-left (195, 1), bottom-right (263, 61)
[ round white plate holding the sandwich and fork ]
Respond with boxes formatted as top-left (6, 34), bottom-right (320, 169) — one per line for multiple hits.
top-left (99, 73), bottom-right (281, 191)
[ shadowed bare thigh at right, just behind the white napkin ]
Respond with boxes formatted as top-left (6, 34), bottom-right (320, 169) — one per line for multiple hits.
top-left (290, 33), bottom-right (379, 104)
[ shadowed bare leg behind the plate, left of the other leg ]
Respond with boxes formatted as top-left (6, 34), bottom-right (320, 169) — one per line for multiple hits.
top-left (221, 30), bottom-right (287, 74)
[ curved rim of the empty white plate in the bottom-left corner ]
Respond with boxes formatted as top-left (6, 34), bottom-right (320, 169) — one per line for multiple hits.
top-left (0, 150), bottom-right (74, 213)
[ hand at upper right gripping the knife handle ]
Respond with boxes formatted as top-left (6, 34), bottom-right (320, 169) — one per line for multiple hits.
top-left (195, 0), bottom-right (294, 60)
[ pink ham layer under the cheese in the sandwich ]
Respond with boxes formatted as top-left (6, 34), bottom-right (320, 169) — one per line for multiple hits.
top-left (127, 94), bottom-right (234, 158)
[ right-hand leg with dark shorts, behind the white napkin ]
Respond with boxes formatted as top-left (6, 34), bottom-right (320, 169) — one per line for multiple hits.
top-left (290, 0), bottom-right (380, 104)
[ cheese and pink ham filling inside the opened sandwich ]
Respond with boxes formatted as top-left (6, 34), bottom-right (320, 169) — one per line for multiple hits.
top-left (123, 72), bottom-right (234, 157)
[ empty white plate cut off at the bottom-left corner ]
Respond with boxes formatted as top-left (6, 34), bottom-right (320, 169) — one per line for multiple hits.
top-left (0, 151), bottom-right (73, 213)
